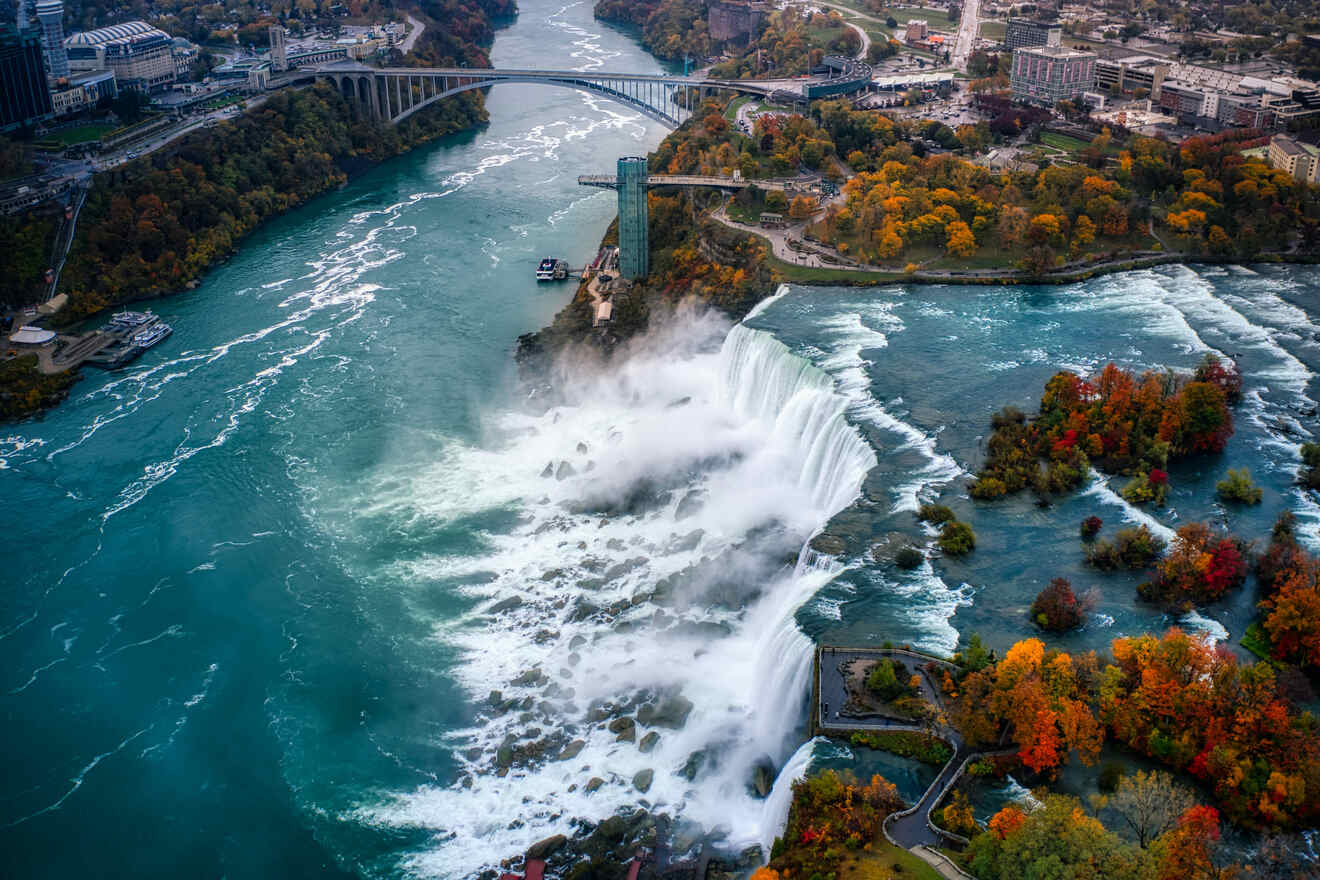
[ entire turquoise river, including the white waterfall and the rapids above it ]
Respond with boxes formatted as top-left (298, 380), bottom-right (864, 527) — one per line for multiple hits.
top-left (0, 0), bottom-right (1320, 877)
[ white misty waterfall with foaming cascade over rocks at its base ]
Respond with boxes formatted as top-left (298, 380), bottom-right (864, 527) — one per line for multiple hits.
top-left (354, 308), bottom-right (875, 877)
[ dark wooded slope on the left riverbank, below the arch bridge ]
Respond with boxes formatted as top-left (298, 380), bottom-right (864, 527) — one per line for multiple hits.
top-left (62, 84), bottom-right (483, 318)
